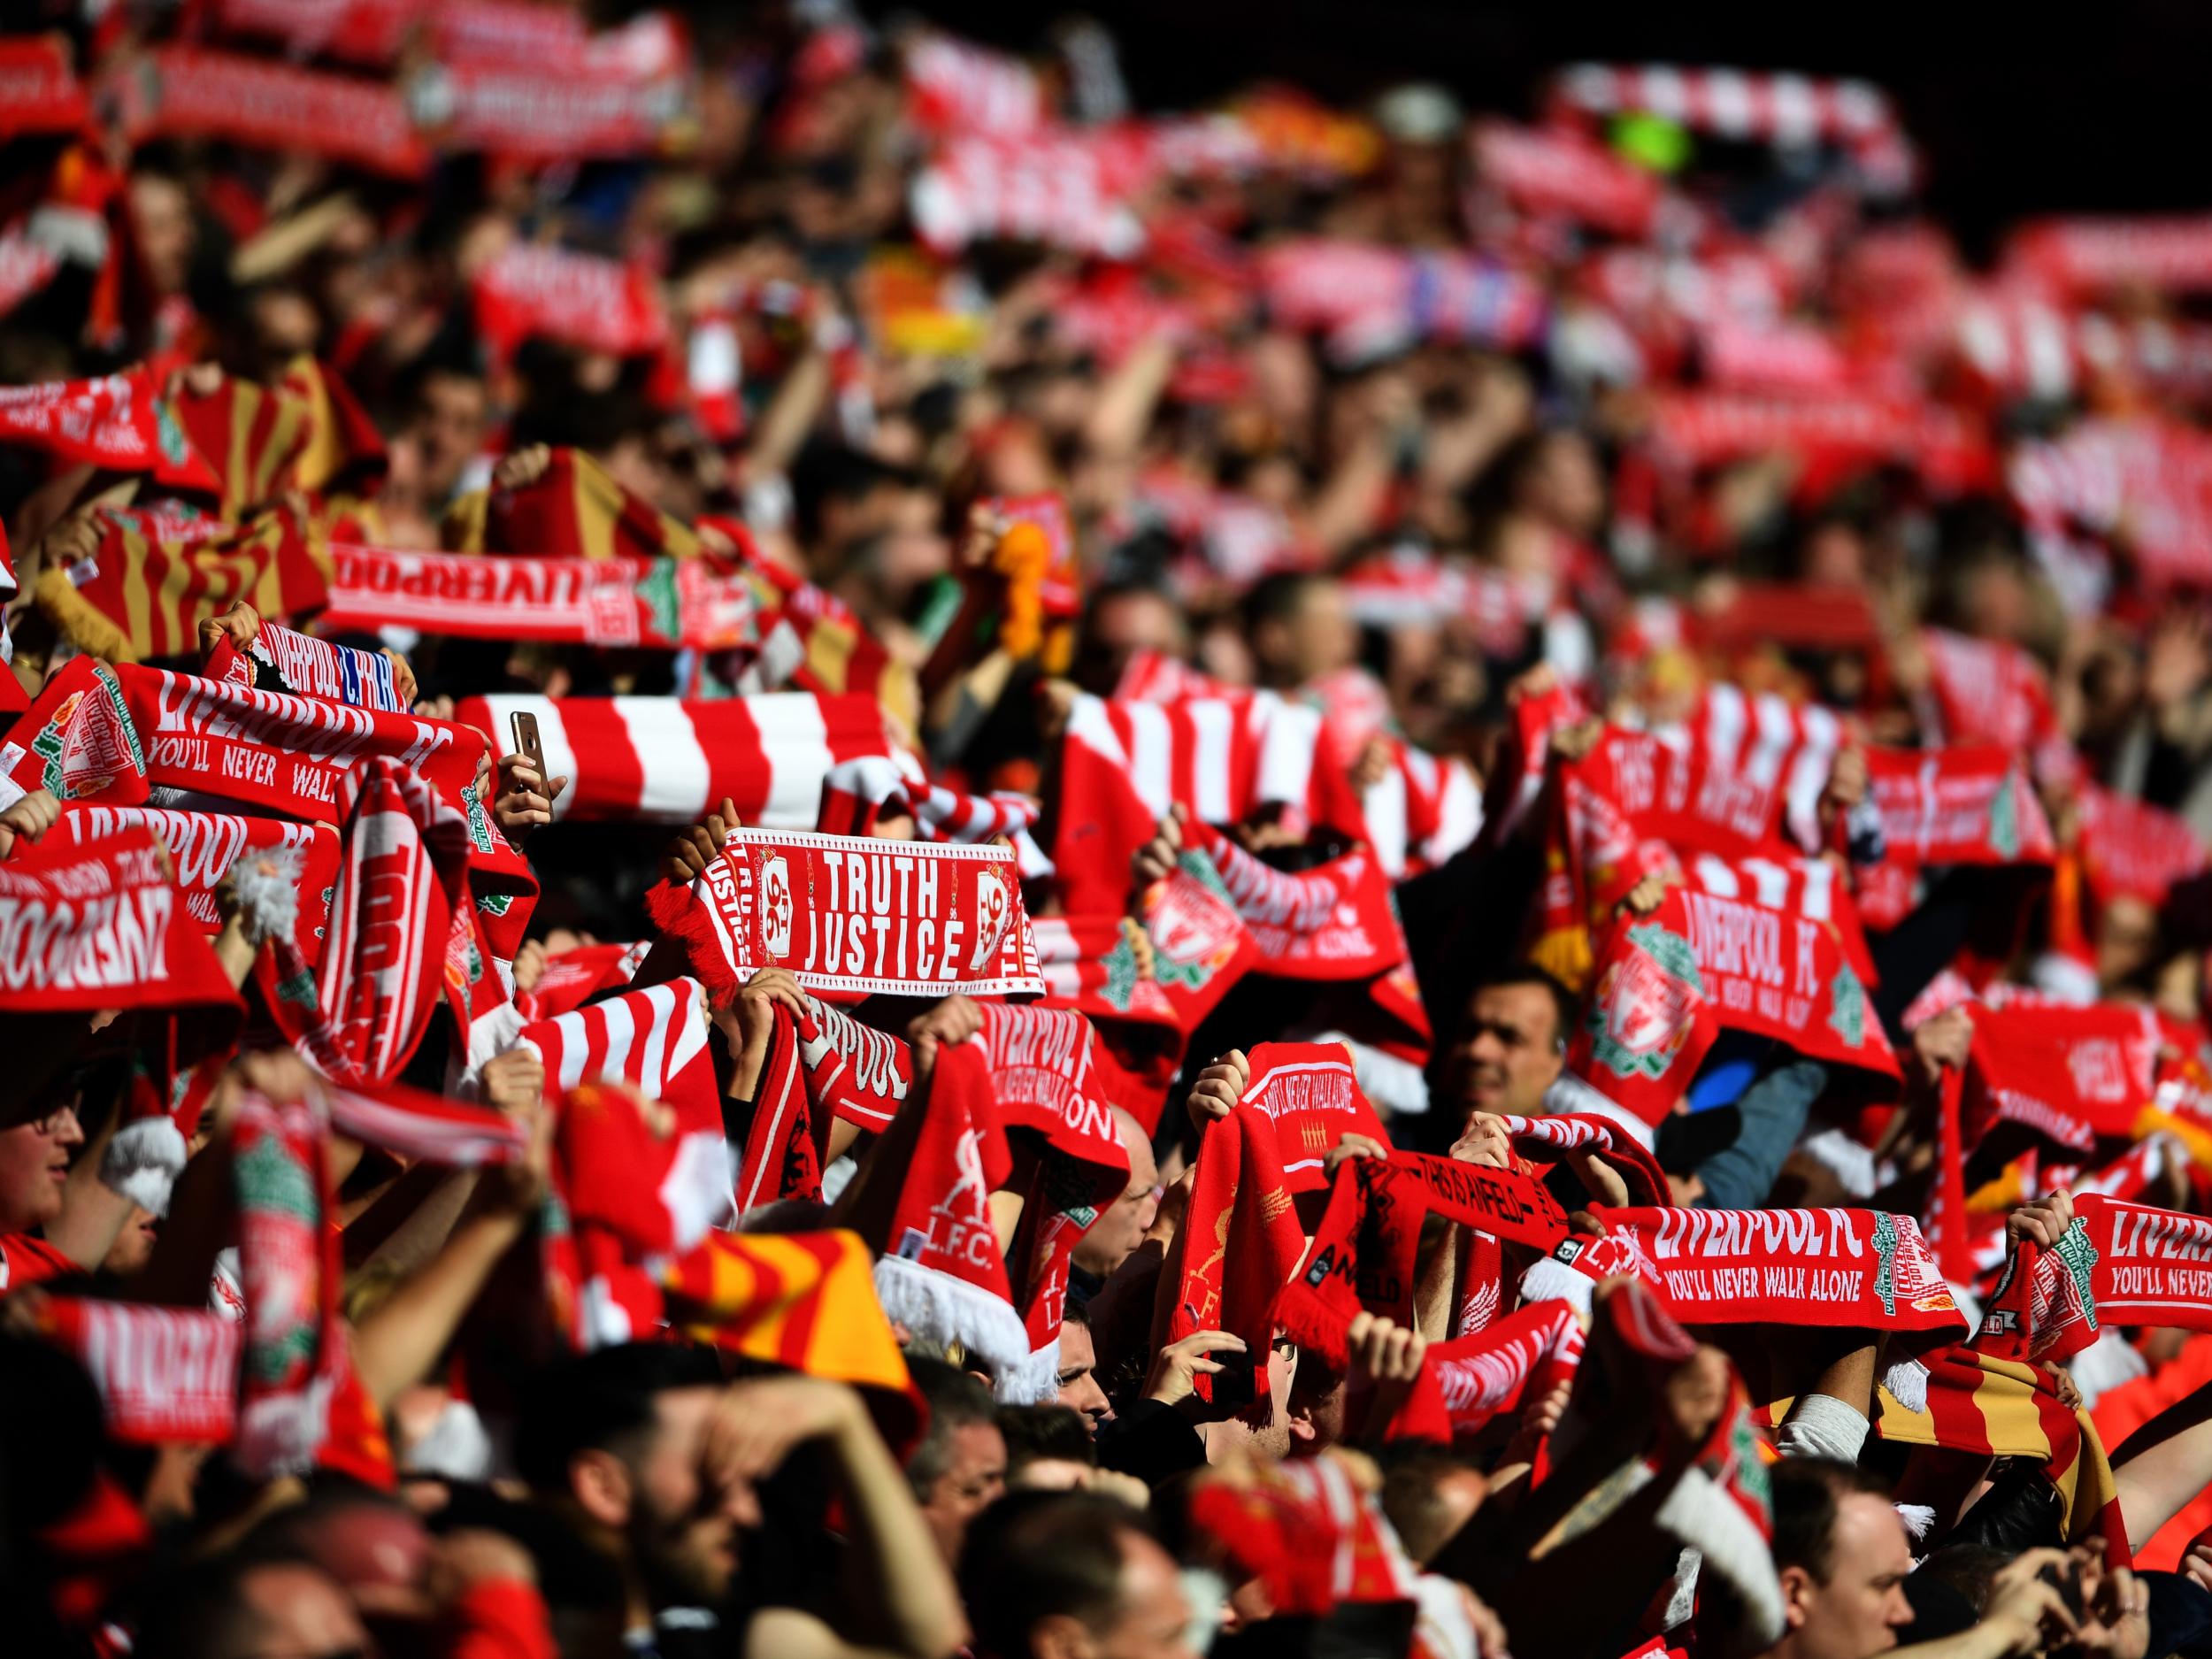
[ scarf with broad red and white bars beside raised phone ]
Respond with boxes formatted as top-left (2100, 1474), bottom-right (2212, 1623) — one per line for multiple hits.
top-left (456, 693), bottom-right (920, 830)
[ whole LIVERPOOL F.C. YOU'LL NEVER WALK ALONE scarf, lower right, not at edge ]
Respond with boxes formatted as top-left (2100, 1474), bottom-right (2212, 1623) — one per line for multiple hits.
top-left (1593, 1206), bottom-right (1960, 1332)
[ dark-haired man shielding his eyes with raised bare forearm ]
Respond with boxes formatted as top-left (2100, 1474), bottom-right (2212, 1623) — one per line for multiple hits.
top-left (516, 1343), bottom-right (973, 1659)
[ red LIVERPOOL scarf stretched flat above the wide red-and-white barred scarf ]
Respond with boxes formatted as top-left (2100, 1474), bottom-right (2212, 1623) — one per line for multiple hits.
top-left (323, 542), bottom-right (759, 650)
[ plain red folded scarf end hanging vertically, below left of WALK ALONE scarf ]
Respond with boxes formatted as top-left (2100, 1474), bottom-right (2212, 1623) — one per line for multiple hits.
top-left (1166, 1104), bottom-right (1305, 1407)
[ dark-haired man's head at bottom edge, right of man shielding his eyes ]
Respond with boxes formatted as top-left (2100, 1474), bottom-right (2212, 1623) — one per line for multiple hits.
top-left (960, 1491), bottom-right (1193, 1659)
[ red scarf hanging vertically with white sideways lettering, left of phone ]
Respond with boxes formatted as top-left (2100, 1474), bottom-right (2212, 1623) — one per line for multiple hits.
top-left (255, 757), bottom-right (469, 1087)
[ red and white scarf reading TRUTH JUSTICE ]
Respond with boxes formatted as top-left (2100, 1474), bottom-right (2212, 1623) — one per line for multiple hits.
top-left (646, 830), bottom-right (1044, 998)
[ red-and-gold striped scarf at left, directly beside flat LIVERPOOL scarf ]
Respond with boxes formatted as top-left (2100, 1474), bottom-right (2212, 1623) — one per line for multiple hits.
top-left (38, 511), bottom-right (330, 662)
